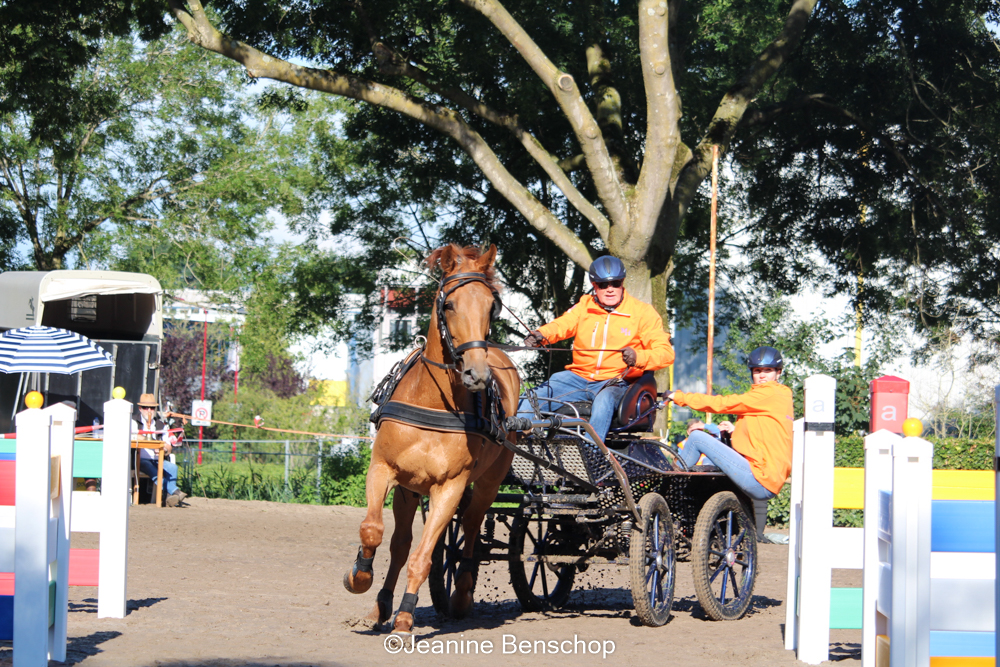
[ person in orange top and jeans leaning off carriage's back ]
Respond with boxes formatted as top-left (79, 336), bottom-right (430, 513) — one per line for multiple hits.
top-left (666, 346), bottom-right (794, 500)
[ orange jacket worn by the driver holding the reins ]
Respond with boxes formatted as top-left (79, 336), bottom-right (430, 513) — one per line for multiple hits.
top-left (538, 292), bottom-right (674, 381)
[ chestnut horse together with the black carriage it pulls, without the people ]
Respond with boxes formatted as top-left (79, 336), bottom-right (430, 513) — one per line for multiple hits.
top-left (344, 246), bottom-right (758, 635)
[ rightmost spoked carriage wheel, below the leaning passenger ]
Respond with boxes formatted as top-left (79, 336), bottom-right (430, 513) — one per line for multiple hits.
top-left (691, 491), bottom-right (757, 621)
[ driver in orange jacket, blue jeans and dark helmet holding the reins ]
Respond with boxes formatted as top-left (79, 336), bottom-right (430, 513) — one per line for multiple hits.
top-left (518, 255), bottom-right (674, 439)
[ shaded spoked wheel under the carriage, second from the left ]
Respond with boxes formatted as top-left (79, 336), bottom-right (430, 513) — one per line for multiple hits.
top-left (508, 516), bottom-right (577, 611)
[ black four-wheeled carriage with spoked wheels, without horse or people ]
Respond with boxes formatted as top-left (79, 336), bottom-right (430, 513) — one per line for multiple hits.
top-left (429, 373), bottom-right (762, 626)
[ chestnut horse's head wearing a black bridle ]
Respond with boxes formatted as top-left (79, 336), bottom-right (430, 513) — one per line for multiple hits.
top-left (427, 244), bottom-right (500, 392)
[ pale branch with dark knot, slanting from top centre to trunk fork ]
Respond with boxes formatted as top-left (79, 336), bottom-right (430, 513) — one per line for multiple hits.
top-left (461, 0), bottom-right (629, 224)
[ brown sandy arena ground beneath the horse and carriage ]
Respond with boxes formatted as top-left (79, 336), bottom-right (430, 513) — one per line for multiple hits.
top-left (0, 498), bottom-right (861, 667)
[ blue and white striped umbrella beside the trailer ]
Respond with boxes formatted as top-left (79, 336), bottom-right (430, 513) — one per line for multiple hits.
top-left (0, 326), bottom-right (113, 375)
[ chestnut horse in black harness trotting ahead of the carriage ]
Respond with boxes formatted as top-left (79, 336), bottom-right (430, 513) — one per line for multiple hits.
top-left (344, 244), bottom-right (521, 635)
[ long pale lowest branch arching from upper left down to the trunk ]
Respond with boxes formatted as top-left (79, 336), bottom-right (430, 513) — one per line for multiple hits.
top-left (170, 0), bottom-right (596, 265)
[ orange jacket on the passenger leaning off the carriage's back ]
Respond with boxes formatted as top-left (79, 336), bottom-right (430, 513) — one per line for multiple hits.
top-left (673, 382), bottom-right (795, 493)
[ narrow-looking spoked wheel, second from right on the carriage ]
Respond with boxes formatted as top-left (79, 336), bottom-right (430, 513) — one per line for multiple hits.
top-left (628, 493), bottom-right (676, 627)
